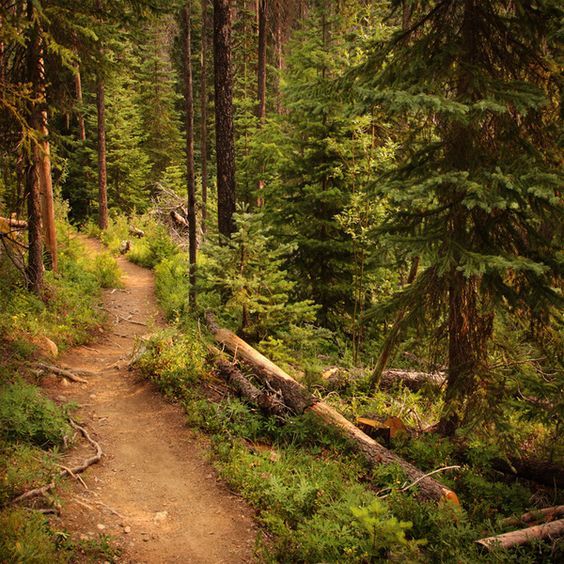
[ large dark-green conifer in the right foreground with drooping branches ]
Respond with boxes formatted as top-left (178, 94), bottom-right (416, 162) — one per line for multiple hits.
top-left (356, 0), bottom-right (561, 433)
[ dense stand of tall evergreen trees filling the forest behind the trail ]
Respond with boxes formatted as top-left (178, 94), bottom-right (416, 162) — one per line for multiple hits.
top-left (0, 0), bottom-right (564, 560)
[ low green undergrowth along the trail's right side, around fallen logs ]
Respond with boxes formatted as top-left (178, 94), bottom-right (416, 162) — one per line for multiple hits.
top-left (113, 210), bottom-right (561, 564)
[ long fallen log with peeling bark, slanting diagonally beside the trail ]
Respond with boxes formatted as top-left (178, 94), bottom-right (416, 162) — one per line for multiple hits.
top-left (206, 313), bottom-right (458, 503)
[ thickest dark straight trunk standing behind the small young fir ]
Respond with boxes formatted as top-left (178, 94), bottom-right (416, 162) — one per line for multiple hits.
top-left (213, 0), bottom-right (235, 238)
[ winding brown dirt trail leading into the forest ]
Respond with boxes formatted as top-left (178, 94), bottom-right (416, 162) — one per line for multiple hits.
top-left (47, 236), bottom-right (256, 563)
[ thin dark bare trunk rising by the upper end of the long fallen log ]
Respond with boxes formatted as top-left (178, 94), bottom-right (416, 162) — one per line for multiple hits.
top-left (182, 0), bottom-right (196, 307)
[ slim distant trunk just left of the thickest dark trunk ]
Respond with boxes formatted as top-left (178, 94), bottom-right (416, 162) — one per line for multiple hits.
top-left (200, 0), bottom-right (208, 235)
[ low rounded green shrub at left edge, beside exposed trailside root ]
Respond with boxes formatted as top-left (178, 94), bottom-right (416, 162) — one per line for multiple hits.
top-left (0, 380), bottom-right (70, 448)
